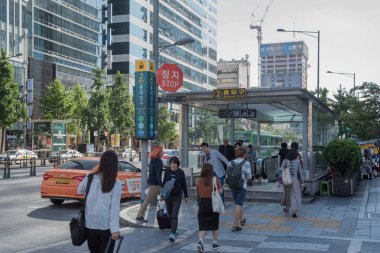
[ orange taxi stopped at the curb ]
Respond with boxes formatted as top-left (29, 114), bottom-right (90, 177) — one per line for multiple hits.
top-left (41, 157), bottom-right (141, 205)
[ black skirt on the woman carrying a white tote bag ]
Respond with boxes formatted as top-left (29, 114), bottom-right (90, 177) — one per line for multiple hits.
top-left (198, 198), bottom-right (219, 231)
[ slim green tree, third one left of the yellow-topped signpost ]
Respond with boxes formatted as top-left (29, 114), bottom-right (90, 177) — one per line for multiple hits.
top-left (67, 83), bottom-right (88, 138)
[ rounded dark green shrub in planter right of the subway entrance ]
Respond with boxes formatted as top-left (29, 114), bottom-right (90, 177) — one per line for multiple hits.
top-left (323, 139), bottom-right (361, 177)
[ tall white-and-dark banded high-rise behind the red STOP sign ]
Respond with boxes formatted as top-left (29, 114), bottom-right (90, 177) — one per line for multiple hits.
top-left (107, 0), bottom-right (217, 91)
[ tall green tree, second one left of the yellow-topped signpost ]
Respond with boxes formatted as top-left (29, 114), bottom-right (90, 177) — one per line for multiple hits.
top-left (84, 69), bottom-right (110, 143)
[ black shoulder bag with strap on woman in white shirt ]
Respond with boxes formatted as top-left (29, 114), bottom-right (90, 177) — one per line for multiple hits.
top-left (70, 174), bottom-right (94, 246)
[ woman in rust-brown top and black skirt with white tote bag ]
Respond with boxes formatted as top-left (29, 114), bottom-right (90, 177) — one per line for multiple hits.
top-left (197, 163), bottom-right (223, 252)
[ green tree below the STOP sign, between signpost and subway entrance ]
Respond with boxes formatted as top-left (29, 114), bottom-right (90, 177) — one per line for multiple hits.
top-left (158, 105), bottom-right (178, 147)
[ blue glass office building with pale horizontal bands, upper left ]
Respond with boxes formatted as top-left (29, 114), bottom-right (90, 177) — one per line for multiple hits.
top-left (32, 0), bottom-right (104, 89)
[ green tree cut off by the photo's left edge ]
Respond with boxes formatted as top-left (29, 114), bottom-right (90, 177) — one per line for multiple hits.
top-left (0, 50), bottom-right (27, 150)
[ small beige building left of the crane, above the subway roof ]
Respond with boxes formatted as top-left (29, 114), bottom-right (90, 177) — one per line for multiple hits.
top-left (217, 55), bottom-right (251, 89)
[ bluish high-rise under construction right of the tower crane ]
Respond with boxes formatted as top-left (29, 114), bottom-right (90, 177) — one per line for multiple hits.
top-left (260, 41), bottom-right (308, 89)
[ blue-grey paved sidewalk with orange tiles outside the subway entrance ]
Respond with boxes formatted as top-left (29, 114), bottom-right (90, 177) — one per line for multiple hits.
top-left (27, 178), bottom-right (380, 253)
